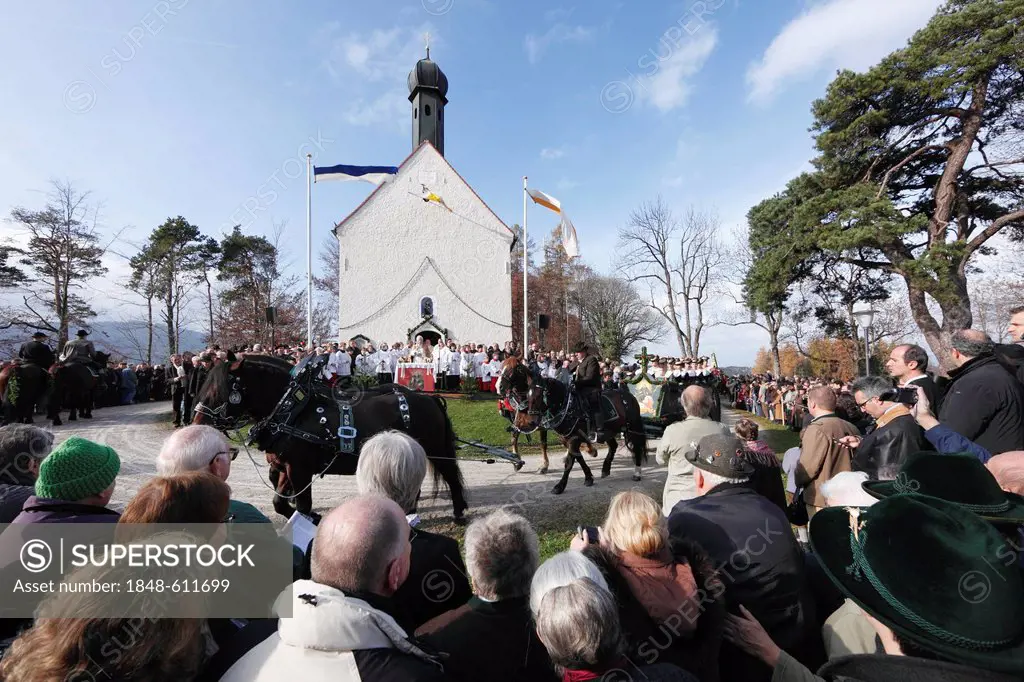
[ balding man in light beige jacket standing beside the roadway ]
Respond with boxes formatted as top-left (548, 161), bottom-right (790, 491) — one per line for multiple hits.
top-left (655, 386), bottom-right (732, 516)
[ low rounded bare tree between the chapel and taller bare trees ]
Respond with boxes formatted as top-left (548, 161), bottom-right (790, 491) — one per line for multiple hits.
top-left (575, 275), bottom-right (665, 359)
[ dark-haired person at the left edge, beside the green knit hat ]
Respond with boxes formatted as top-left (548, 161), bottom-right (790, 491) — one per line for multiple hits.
top-left (0, 424), bottom-right (53, 523)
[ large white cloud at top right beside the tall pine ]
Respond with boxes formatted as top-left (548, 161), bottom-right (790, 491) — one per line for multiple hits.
top-left (746, 0), bottom-right (944, 103)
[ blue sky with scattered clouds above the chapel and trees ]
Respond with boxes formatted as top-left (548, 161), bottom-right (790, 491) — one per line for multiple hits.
top-left (0, 0), bottom-right (940, 364)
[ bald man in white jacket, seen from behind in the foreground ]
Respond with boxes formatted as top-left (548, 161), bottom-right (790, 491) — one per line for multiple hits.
top-left (220, 495), bottom-right (445, 682)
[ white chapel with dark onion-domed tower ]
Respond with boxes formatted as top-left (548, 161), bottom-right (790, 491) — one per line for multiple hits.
top-left (334, 51), bottom-right (515, 345)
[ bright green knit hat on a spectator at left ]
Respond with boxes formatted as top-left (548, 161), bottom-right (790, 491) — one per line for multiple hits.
top-left (36, 436), bottom-right (121, 502)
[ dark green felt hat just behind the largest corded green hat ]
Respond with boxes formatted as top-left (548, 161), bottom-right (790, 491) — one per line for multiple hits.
top-left (863, 453), bottom-right (1024, 525)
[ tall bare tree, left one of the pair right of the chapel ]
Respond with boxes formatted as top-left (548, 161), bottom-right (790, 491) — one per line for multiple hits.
top-left (616, 197), bottom-right (689, 354)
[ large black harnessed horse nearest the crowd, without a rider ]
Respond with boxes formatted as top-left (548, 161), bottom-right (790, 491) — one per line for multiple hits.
top-left (193, 355), bottom-right (468, 519)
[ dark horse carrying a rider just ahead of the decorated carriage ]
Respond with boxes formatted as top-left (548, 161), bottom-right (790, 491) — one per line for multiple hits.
top-left (527, 378), bottom-right (647, 495)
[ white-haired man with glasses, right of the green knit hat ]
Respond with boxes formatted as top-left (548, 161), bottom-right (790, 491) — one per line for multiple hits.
top-left (157, 424), bottom-right (270, 523)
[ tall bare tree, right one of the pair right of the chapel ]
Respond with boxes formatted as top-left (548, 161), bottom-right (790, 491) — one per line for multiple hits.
top-left (673, 207), bottom-right (726, 357)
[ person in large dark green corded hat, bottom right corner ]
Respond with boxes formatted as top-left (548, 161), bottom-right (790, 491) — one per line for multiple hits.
top-left (723, 489), bottom-right (1024, 682)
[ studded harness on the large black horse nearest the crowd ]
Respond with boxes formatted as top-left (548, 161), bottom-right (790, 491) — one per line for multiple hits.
top-left (247, 355), bottom-right (411, 455)
